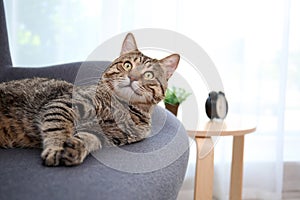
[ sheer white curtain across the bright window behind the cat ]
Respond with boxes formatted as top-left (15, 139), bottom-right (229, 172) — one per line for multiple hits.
top-left (5, 0), bottom-right (300, 199)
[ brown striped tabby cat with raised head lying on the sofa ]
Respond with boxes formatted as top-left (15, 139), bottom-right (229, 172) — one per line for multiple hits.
top-left (0, 33), bottom-right (180, 166)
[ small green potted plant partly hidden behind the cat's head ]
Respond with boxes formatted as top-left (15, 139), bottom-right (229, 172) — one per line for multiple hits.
top-left (164, 86), bottom-right (191, 116)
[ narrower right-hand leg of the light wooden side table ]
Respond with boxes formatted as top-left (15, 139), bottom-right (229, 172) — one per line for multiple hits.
top-left (230, 135), bottom-right (244, 200)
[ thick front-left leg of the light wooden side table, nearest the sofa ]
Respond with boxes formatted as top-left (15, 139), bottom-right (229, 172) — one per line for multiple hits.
top-left (194, 137), bottom-right (214, 200)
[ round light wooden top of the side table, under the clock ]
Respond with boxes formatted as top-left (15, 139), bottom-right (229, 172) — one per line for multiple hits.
top-left (187, 118), bottom-right (256, 137)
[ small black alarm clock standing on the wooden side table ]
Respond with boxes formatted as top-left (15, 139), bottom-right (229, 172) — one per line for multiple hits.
top-left (205, 91), bottom-right (228, 119)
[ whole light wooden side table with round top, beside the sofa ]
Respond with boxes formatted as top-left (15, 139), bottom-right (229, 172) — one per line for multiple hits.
top-left (188, 119), bottom-right (256, 200)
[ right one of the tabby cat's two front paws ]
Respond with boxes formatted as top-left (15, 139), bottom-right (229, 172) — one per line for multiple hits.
top-left (60, 137), bottom-right (89, 166)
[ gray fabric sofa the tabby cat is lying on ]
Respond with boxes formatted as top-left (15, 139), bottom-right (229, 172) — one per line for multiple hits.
top-left (0, 0), bottom-right (189, 200)
